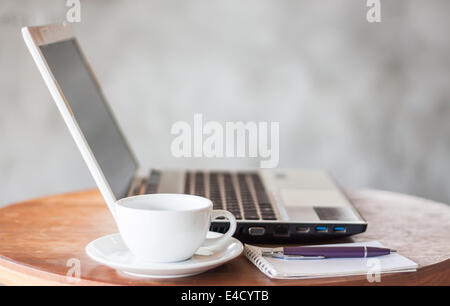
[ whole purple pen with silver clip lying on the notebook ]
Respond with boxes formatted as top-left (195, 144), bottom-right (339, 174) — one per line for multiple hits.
top-left (262, 246), bottom-right (396, 259)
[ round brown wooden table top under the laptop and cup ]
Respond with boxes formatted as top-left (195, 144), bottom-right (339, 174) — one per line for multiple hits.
top-left (0, 190), bottom-right (450, 285)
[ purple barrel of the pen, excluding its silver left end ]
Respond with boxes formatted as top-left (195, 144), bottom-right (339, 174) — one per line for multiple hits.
top-left (283, 246), bottom-right (390, 258)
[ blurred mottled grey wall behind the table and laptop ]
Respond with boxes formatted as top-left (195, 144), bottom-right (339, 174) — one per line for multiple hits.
top-left (0, 0), bottom-right (450, 205)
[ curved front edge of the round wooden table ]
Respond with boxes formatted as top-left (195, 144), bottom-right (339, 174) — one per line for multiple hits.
top-left (0, 256), bottom-right (450, 286)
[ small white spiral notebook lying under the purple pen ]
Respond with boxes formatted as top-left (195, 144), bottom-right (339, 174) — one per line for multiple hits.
top-left (244, 241), bottom-right (418, 279)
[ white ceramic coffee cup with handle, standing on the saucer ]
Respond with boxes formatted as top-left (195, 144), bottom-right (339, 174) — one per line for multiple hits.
top-left (115, 193), bottom-right (236, 262)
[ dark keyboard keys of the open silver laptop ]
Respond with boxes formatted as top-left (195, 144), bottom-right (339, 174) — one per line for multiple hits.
top-left (133, 170), bottom-right (278, 220)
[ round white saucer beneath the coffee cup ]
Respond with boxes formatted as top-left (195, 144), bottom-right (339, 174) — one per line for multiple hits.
top-left (86, 232), bottom-right (244, 278)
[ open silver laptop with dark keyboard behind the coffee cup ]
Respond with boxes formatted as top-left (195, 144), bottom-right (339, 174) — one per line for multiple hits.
top-left (22, 25), bottom-right (367, 243)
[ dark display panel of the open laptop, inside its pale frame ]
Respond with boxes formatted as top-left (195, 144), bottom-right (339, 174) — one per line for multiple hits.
top-left (40, 39), bottom-right (137, 199)
